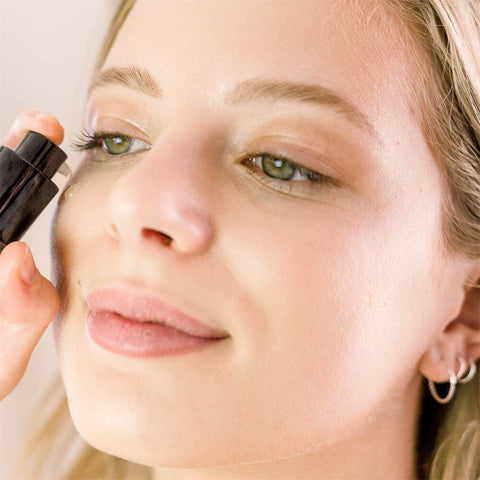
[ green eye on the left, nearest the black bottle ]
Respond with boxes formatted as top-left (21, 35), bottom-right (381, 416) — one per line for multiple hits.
top-left (72, 130), bottom-right (152, 155)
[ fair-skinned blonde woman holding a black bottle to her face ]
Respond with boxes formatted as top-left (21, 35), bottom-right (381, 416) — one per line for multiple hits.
top-left (0, 0), bottom-right (480, 479)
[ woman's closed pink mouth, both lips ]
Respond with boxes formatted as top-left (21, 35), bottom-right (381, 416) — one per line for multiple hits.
top-left (85, 286), bottom-right (229, 357)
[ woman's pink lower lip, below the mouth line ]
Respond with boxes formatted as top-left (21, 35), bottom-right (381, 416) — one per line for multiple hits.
top-left (87, 312), bottom-right (222, 357)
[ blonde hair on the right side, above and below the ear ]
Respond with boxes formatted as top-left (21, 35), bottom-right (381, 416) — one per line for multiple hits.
top-left (387, 0), bottom-right (480, 480)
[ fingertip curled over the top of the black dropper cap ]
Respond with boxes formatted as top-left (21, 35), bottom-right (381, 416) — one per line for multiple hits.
top-left (2, 110), bottom-right (65, 150)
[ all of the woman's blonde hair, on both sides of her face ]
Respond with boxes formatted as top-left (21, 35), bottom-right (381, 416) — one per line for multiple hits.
top-left (6, 0), bottom-right (480, 480)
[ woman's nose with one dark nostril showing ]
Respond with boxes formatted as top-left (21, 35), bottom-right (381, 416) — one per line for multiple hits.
top-left (107, 133), bottom-right (213, 254)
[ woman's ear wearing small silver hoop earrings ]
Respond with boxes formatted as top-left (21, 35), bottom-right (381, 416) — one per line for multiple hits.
top-left (418, 270), bottom-right (480, 382)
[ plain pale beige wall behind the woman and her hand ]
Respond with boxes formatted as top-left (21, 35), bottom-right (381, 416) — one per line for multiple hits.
top-left (0, 0), bottom-right (115, 479)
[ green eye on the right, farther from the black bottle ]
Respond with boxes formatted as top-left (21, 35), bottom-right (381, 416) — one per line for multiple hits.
top-left (242, 153), bottom-right (334, 193)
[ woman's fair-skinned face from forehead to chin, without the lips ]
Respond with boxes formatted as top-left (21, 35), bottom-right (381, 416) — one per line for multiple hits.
top-left (54, 0), bottom-right (472, 467)
